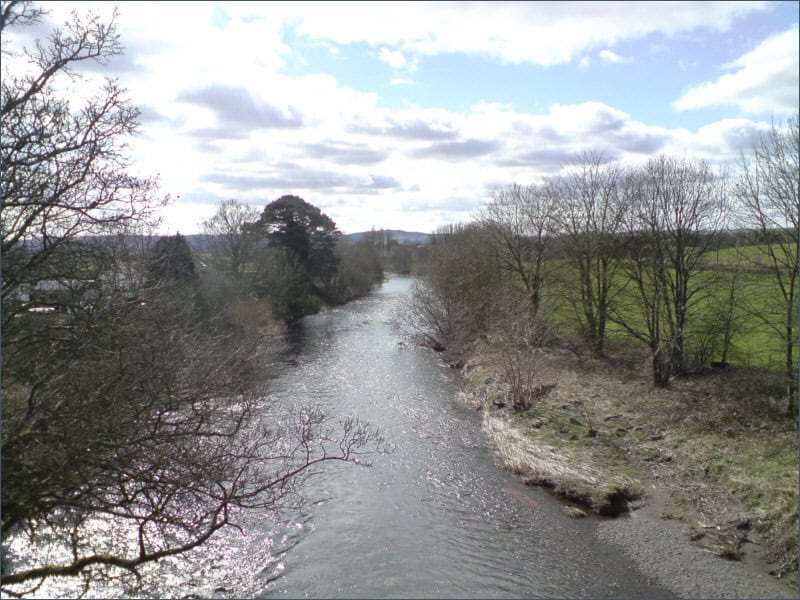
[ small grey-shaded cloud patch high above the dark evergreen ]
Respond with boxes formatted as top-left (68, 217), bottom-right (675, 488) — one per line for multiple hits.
top-left (177, 84), bottom-right (303, 129)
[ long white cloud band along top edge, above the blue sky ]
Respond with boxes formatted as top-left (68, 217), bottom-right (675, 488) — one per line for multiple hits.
top-left (284, 2), bottom-right (768, 66)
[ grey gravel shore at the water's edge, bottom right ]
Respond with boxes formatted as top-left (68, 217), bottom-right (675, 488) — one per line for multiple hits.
top-left (597, 511), bottom-right (797, 598)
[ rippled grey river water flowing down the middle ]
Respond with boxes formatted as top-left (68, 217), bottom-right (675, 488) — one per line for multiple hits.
top-left (250, 277), bottom-right (669, 598)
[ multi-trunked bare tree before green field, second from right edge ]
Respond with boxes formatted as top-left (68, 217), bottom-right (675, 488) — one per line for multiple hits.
top-left (614, 156), bottom-right (726, 387)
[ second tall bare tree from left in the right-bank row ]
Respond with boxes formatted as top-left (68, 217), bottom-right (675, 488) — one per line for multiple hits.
top-left (551, 152), bottom-right (628, 356)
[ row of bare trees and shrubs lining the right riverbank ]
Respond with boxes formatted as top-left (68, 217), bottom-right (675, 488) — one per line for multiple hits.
top-left (407, 120), bottom-right (800, 417)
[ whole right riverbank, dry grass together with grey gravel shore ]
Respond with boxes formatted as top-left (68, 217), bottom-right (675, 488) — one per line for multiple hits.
top-left (456, 348), bottom-right (798, 597)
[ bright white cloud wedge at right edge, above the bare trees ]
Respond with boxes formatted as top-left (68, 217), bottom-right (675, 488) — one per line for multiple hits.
top-left (672, 25), bottom-right (800, 115)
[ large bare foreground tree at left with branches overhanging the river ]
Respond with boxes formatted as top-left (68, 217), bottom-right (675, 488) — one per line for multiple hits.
top-left (0, 2), bottom-right (377, 596)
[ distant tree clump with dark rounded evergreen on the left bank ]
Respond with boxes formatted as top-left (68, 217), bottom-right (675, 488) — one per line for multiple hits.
top-left (198, 195), bottom-right (415, 321)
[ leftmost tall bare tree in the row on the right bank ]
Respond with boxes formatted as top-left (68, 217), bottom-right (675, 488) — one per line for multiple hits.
top-left (479, 184), bottom-right (557, 319)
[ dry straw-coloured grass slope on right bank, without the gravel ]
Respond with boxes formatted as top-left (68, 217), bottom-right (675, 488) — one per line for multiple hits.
top-left (465, 350), bottom-right (798, 575)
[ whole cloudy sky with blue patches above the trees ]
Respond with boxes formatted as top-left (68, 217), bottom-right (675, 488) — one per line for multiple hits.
top-left (7, 1), bottom-right (800, 234)
